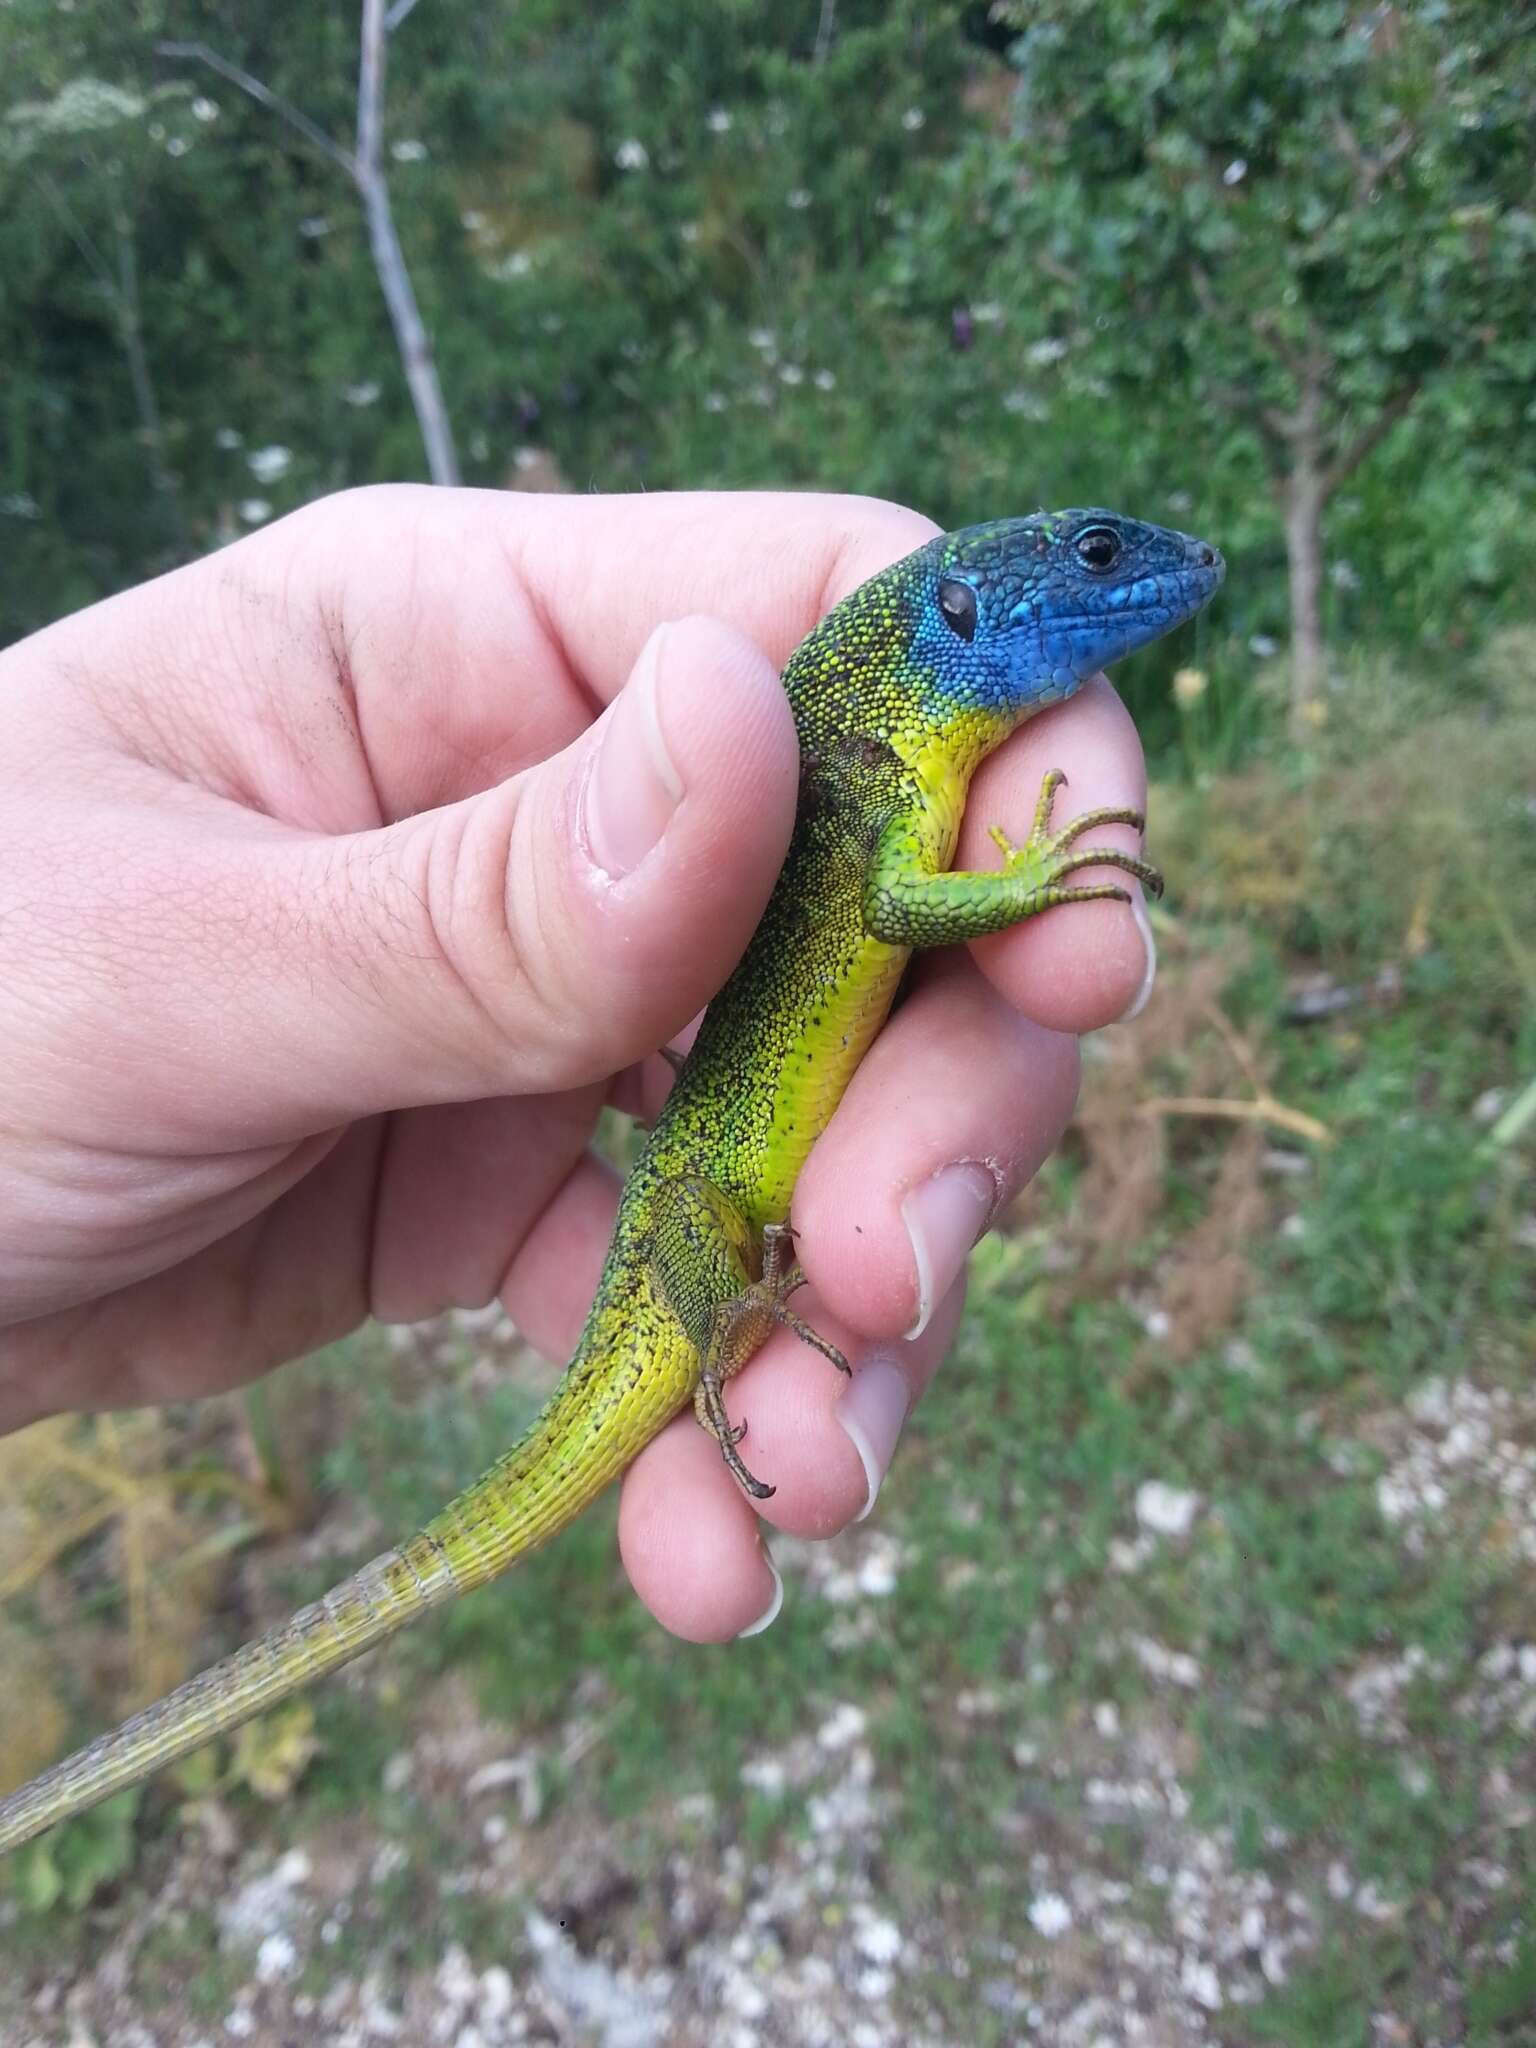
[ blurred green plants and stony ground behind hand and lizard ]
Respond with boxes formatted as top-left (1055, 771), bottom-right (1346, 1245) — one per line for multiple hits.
top-left (0, 0), bottom-right (1536, 2048)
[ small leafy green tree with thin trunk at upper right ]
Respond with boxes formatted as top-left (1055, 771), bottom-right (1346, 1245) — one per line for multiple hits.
top-left (928, 0), bottom-right (1536, 735)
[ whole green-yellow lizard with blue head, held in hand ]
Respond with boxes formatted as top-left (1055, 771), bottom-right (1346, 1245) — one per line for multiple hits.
top-left (0, 510), bottom-right (1225, 1853)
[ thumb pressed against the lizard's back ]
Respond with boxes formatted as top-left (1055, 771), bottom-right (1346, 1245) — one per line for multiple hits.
top-left (129, 618), bottom-right (799, 1145)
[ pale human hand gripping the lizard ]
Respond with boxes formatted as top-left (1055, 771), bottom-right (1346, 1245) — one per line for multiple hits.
top-left (0, 487), bottom-right (1149, 1640)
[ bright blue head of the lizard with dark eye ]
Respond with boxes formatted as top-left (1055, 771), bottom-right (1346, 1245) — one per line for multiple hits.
top-left (918, 510), bottom-right (1227, 717)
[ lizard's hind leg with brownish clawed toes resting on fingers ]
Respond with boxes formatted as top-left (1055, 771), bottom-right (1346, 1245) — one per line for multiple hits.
top-left (649, 1176), bottom-right (848, 1501)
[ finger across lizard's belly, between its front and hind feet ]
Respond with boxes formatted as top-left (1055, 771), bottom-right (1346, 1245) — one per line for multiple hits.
top-left (795, 954), bottom-right (1077, 1337)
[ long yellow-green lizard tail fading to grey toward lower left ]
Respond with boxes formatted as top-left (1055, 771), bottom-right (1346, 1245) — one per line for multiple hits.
top-left (0, 1352), bottom-right (655, 1855)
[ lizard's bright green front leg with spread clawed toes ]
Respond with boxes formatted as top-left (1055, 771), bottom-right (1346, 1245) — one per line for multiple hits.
top-left (864, 768), bottom-right (1163, 946)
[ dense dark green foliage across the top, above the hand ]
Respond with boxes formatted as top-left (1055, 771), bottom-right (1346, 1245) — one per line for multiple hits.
top-left (0, 0), bottom-right (1536, 745)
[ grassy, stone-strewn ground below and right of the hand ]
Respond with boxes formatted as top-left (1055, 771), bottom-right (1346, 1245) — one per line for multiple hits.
top-left (0, 659), bottom-right (1536, 2048)
